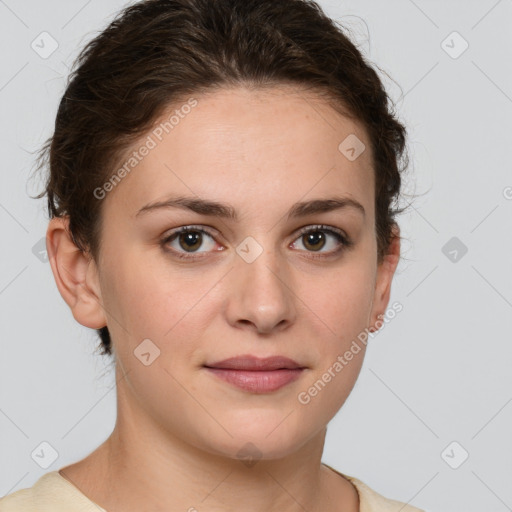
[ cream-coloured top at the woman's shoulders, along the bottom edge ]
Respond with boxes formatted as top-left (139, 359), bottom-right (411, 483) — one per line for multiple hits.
top-left (0, 463), bottom-right (425, 512)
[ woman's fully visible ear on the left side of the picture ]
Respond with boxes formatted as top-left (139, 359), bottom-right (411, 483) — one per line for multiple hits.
top-left (46, 217), bottom-right (107, 329)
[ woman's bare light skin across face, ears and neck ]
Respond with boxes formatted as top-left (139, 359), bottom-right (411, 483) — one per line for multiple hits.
top-left (47, 86), bottom-right (400, 512)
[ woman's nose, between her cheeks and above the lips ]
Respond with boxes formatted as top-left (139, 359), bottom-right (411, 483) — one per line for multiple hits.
top-left (226, 244), bottom-right (298, 334)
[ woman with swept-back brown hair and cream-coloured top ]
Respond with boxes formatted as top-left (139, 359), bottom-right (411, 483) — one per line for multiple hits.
top-left (0, 0), bottom-right (419, 512)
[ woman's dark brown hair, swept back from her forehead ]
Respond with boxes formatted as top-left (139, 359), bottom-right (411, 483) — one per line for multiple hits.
top-left (37, 0), bottom-right (408, 354)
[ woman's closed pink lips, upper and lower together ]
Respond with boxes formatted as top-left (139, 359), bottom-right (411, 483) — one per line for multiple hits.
top-left (205, 355), bottom-right (304, 393)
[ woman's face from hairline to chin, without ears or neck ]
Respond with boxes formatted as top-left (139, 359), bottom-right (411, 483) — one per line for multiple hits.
top-left (90, 87), bottom-right (395, 459)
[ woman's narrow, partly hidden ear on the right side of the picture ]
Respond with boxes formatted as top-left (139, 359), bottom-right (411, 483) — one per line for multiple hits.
top-left (368, 224), bottom-right (400, 332)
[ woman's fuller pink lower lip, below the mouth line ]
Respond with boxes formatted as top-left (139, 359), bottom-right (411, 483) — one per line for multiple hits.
top-left (206, 367), bottom-right (303, 393)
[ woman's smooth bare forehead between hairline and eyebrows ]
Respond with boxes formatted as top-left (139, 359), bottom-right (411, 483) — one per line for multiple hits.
top-left (105, 86), bottom-right (374, 223)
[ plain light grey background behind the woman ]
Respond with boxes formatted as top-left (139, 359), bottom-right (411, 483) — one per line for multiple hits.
top-left (0, 0), bottom-right (512, 512)
